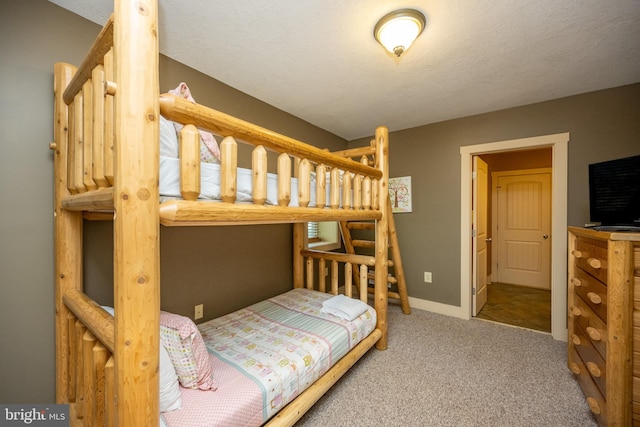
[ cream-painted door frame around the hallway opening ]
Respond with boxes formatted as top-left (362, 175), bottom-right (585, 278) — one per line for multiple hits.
top-left (460, 132), bottom-right (570, 341)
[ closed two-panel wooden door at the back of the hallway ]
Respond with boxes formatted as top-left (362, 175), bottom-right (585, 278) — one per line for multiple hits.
top-left (494, 170), bottom-right (551, 289)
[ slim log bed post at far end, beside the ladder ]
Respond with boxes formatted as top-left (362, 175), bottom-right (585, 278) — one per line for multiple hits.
top-left (374, 126), bottom-right (391, 350)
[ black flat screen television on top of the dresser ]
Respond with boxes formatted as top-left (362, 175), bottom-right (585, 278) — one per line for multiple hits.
top-left (589, 155), bottom-right (640, 230)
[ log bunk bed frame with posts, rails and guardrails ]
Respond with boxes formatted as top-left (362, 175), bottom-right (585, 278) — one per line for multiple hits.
top-left (51, 0), bottom-right (388, 426)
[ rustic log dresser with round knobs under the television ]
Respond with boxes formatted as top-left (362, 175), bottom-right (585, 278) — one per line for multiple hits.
top-left (568, 227), bottom-right (640, 426)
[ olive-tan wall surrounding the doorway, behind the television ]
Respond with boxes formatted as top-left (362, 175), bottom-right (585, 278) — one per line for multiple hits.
top-left (349, 83), bottom-right (640, 306)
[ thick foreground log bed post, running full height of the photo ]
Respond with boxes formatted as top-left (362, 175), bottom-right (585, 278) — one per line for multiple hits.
top-left (114, 0), bottom-right (160, 426)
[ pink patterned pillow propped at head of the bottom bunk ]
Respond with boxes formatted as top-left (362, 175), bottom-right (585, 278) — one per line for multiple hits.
top-left (160, 311), bottom-right (218, 390)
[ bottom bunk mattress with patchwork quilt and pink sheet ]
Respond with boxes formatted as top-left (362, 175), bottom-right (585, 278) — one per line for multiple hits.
top-left (162, 289), bottom-right (376, 427)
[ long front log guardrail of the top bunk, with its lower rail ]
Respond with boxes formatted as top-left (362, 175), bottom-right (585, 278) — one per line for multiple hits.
top-left (160, 94), bottom-right (387, 225)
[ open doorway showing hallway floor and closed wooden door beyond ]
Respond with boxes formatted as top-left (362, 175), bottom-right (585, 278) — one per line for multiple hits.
top-left (473, 158), bottom-right (552, 333)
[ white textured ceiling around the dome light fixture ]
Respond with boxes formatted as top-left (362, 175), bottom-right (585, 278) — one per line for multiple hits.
top-left (50, 0), bottom-right (640, 140)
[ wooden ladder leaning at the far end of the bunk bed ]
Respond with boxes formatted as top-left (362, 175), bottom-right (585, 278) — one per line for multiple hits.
top-left (340, 200), bottom-right (411, 314)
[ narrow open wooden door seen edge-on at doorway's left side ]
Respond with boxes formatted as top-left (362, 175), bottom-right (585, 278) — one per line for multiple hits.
top-left (472, 156), bottom-right (489, 316)
